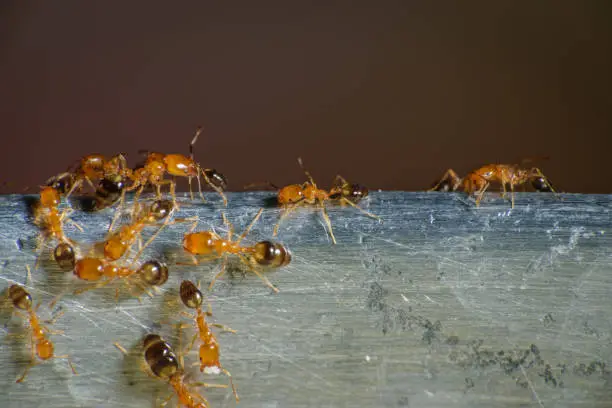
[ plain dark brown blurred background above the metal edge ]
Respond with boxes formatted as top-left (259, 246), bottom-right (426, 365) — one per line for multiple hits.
top-left (0, 0), bottom-right (612, 193)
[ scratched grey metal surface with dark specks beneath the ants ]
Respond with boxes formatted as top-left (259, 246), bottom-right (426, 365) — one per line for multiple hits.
top-left (0, 192), bottom-right (612, 408)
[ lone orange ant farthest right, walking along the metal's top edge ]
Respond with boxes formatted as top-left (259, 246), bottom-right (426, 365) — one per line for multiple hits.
top-left (429, 164), bottom-right (555, 208)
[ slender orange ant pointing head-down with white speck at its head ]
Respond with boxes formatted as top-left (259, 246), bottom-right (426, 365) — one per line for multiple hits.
top-left (179, 280), bottom-right (240, 402)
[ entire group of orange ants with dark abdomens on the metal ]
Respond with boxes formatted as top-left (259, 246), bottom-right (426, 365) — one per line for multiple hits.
top-left (8, 128), bottom-right (554, 408)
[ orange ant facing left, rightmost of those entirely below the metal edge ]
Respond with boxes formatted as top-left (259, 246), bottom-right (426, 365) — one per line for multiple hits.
top-left (183, 208), bottom-right (291, 293)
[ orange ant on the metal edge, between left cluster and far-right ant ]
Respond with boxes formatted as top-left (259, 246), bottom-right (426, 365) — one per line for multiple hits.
top-left (273, 157), bottom-right (380, 244)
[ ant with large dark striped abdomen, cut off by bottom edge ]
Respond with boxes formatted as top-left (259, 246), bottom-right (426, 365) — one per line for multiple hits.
top-left (115, 334), bottom-right (227, 408)
